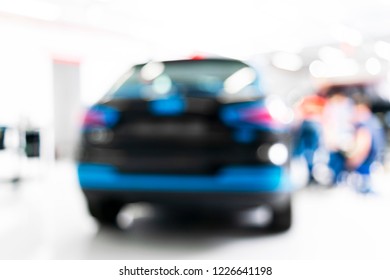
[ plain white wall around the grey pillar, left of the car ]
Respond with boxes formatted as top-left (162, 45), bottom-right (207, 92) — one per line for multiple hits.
top-left (0, 15), bottom-right (157, 126)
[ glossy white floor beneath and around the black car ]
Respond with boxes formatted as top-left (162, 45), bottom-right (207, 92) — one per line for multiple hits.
top-left (0, 160), bottom-right (390, 259)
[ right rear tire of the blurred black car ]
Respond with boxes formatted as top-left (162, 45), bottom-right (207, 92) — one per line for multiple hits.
top-left (269, 199), bottom-right (292, 232)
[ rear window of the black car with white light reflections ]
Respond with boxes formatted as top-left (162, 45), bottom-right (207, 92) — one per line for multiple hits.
top-left (107, 60), bottom-right (261, 99)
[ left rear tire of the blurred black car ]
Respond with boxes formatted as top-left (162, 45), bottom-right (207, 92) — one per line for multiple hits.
top-left (88, 200), bottom-right (123, 227)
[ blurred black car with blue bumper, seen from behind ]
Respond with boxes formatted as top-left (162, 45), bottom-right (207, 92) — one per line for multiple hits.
top-left (78, 59), bottom-right (291, 231)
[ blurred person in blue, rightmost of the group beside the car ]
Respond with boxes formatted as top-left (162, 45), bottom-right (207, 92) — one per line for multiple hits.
top-left (346, 92), bottom-right (386, 193)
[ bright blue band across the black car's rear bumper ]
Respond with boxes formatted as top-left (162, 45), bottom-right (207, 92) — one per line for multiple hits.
top-left (77, 163), bottom-right (291, 194)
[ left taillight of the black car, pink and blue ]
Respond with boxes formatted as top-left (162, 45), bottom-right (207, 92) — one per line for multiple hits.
top-left (83, 105), bottom-right (119, 128)
